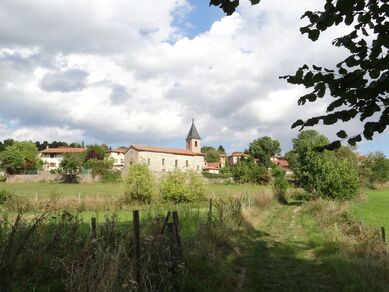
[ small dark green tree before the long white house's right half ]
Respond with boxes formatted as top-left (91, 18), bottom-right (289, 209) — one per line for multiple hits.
top-left (58, 154), bottom-right (83, 183)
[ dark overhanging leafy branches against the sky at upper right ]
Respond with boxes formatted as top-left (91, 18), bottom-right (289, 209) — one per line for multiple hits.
top-left (210, 0), bottom-right (389, 146)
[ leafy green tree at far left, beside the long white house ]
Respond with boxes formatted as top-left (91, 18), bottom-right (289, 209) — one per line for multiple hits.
top-left (0, 140), bottom-right (42, 174)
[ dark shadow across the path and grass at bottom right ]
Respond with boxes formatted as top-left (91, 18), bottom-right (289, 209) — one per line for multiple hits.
top-left (226, 216), bottom-right (389, 291)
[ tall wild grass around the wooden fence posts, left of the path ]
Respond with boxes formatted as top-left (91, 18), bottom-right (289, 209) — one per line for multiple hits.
top-left (0, 190), bottom-right (271, 291)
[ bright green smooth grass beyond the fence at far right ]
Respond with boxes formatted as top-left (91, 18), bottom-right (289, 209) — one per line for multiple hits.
top-left (353, 189), bottom-right (389, 229)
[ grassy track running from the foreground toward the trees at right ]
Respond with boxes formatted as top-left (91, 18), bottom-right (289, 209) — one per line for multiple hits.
top-left (237, 205), bottom-right (336, 291)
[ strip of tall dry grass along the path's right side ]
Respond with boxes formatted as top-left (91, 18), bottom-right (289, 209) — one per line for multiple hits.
top-left (303, 199), bottom-right (389, 291)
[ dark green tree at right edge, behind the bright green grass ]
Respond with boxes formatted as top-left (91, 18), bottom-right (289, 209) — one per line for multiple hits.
top-left (361, 152), bottom-right (389, 187)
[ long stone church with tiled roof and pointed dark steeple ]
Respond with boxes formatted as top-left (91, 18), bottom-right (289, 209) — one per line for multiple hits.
top-left (124, 120), bottom-right (206, 172)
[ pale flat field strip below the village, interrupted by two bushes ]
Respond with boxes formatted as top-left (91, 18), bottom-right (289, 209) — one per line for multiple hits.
top-left (0, 183), bottom-right (261, 198)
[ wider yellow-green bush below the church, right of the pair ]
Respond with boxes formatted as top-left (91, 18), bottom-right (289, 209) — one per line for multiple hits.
top-left (160, 170), bottom-right (205, 204)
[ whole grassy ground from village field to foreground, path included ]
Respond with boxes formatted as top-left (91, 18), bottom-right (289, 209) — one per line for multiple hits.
top-left (0, 183), bottom-right (389, 291)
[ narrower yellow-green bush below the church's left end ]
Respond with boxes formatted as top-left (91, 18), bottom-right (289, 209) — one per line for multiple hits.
top-left (123, 164), bottom-right (154, 203)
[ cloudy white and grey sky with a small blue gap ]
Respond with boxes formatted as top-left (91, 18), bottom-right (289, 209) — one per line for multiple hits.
top-left (0, 0), bottom-right (389, 155)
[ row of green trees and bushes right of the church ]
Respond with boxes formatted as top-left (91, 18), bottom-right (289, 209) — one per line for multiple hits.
top-left (218, 130), bottom-right (389, 200)
